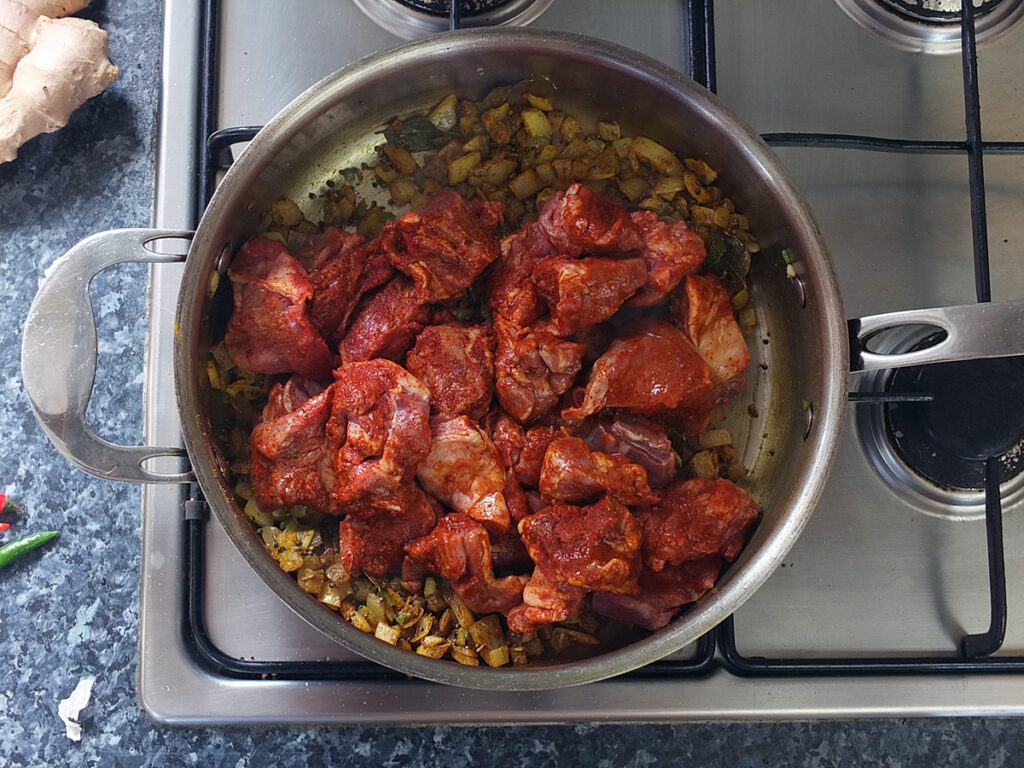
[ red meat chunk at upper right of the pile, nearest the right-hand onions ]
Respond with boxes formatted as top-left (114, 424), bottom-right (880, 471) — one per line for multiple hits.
top-left (629, 211), bottom-right (708, 306)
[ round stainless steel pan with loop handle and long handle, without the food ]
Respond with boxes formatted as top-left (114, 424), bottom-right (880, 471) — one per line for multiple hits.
top-left (23, 29), bottom-right (1024, 690)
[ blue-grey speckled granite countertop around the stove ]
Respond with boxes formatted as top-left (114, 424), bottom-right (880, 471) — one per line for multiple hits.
top-left (0, 0), bottom-right (1024, 768)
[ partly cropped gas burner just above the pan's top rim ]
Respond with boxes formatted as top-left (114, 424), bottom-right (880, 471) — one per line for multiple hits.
top-left (354, 0), bottom-right (554, 40)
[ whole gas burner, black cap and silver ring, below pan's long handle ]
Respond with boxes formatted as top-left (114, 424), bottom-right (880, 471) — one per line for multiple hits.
top-left (856, 330), bottom-right (1024, 520)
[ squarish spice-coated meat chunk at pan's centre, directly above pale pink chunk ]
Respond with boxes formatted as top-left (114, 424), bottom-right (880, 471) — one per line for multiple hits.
top-left (406, 324), bottom-right (497, 419)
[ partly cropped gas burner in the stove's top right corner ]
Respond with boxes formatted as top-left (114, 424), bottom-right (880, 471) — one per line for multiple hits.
top-left (836, 0), bottom-right (1024, 53)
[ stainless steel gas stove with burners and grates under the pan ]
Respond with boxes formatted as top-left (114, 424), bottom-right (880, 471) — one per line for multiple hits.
top-left (138, 0), bottom-right (1024, 725)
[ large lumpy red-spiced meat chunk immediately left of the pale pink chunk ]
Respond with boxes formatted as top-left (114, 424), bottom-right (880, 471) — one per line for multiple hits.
top-left (327, 359), bottom-right (430, 514)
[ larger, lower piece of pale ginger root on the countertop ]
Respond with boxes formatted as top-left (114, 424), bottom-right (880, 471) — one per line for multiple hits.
top-left (0, 14), bottom-right (120, 163)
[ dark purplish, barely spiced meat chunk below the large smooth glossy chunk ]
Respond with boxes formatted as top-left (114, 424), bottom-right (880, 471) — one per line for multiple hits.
top-left (584, 412), bottom-right (676, 488)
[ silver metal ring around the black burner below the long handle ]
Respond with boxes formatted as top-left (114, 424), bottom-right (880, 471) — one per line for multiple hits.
top-left (855, 327), bottom-right (1024, 520)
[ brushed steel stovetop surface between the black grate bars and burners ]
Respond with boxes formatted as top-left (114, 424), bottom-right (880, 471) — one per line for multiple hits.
top-left (139, 0), bottom-right (1024, 723)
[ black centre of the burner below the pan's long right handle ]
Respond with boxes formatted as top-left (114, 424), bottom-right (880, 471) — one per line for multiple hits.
top-left (886, 344), bottom-right (1024, 490)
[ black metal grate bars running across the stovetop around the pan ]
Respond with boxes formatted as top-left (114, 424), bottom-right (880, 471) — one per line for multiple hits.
top-left (188, 0), bottom-right (1024, 683)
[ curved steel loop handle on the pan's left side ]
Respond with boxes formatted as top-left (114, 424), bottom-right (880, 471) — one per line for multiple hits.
top-left (22, 229), bottom-right (194, 482)
